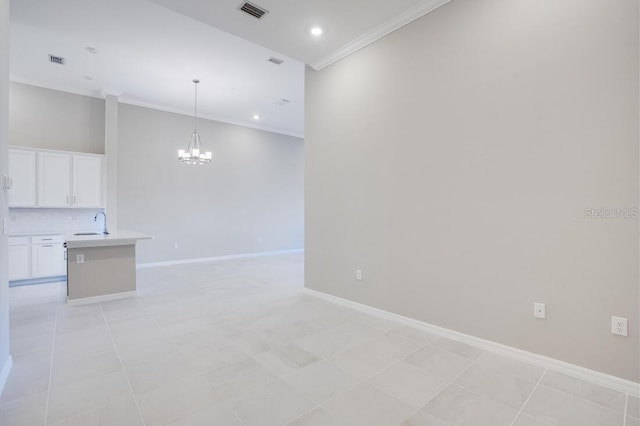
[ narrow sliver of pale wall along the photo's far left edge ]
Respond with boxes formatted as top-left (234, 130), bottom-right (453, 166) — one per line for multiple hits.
top-left (0, 0), bottom-right (9, 386)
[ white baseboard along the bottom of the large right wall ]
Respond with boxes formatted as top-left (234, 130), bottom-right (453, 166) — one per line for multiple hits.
top-left (304, 288), bottom-right (640, 397)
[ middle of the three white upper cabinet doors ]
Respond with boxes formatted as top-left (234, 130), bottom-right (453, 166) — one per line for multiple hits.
top-left (38, 152), bottom-right (71, 207)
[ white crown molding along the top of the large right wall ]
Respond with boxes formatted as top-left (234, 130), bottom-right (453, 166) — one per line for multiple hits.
top-left (309, 0), bottom-right (450, 71)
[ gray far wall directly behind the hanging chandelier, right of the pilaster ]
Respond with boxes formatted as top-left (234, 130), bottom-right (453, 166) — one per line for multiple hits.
top-left (117, 104), bottom-right (304, 263)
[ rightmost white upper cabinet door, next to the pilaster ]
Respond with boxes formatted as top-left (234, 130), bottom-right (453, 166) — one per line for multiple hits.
top-left (72, 155), bottom-right (102, 207)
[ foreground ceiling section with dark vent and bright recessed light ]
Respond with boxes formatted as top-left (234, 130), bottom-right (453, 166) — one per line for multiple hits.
top-left (151, 0), bottom-right (449, 69)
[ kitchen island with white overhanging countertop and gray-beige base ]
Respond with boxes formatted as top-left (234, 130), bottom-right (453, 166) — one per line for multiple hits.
top-left (65, 231), bottom-right (152, 304)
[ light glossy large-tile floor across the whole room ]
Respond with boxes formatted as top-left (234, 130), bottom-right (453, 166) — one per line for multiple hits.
top-left (0, 254), bottom-right (640, 426)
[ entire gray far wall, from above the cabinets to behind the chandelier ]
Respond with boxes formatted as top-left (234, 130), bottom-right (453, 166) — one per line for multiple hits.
top-left (9, 82), bottom-right (304, 263)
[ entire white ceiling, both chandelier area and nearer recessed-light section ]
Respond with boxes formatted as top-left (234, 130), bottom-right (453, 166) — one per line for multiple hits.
top-left (10, 0), bottom-right (449, 137)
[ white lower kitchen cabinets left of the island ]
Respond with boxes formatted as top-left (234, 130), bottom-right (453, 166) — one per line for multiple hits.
top-left (9, 235), bottom-right (67, 281)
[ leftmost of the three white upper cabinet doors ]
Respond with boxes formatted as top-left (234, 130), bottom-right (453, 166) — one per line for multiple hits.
top-left (9, 149), bottom-right (36, 207)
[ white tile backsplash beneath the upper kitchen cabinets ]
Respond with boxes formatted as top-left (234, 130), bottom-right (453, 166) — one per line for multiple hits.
top-left (9, 208), bottom-right (104, 235)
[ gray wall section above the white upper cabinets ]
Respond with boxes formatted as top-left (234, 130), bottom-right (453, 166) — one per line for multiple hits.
top-left (9, 82), bottom-right (104, 154)
